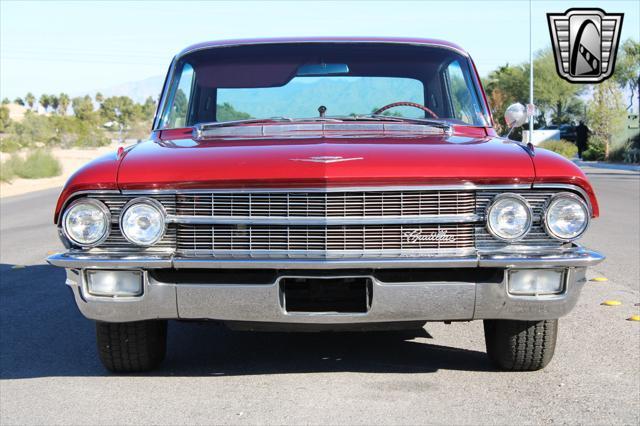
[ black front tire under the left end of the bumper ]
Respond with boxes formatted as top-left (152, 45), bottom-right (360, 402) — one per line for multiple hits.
top-left (96, 320), bottom-right (167, 373)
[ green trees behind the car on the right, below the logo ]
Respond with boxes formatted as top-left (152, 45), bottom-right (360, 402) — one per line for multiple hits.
top-left (483, 39), bottom-right (640, 160)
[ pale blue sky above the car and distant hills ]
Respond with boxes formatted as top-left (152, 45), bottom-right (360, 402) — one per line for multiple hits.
top-left (0, 0), bottom-right (640, 99)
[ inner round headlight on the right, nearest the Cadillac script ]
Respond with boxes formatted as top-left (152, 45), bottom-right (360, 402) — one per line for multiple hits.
top-left (487, 194), bottom-right (532, 241)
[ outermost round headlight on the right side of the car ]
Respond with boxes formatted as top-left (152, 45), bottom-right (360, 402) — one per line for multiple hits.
top-left (544, 192), bottom-right (589, 241)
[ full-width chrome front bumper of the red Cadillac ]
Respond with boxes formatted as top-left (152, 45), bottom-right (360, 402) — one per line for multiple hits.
top-left (47, 247), bottom-right (604, 324)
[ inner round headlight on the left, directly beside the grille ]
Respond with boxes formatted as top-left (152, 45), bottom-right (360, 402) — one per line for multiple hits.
top-left (120, 198), bottom-right (165, 246)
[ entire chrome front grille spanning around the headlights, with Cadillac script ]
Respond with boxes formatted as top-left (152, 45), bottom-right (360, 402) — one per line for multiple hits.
top-left (63, 189), bottom-right (584, 257)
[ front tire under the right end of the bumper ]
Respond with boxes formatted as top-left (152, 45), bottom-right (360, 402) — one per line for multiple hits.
top-left (484, 319), bottom-right (558, 371)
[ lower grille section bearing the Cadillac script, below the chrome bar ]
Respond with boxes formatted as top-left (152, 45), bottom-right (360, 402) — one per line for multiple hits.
top-left (177, 224), bottom-right (474, 255)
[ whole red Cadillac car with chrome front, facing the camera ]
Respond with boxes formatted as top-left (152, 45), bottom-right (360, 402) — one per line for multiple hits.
top-left (48, 38), bottom-right (603, 372)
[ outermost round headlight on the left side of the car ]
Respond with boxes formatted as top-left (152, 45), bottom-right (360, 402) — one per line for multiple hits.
top-left (62, 198), bottom-right (111, 247)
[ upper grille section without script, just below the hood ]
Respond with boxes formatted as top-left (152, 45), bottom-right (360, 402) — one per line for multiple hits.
top-left (176, 191), bottom-right (476, 217)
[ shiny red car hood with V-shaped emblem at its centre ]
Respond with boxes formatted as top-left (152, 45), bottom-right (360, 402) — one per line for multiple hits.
top-left (118, 136), bottom-right (534, 190)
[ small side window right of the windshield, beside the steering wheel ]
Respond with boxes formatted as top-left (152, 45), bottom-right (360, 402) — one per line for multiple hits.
top-left (445, 61), bottom-right (484, 125)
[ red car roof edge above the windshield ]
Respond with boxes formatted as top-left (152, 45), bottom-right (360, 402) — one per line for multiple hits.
top-left (176, 37), bottom-right (469, 58)
